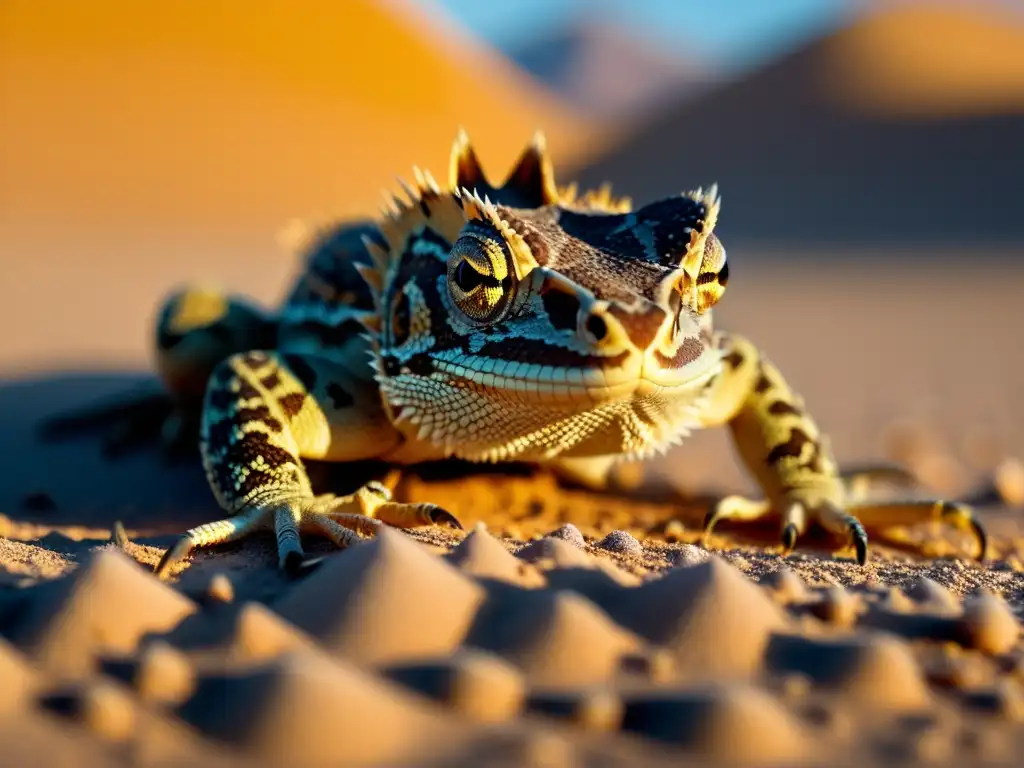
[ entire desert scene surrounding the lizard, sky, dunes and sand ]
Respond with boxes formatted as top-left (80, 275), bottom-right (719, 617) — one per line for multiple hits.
top-left (0, 0), bottom-right (1024, 765)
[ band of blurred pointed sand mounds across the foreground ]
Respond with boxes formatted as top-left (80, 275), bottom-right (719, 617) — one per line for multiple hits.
top-left (0, 512), bottom-right (1024, 766)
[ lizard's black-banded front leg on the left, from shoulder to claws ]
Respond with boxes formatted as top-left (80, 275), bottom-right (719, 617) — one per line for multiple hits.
top-left (156, 351), bottom-right (461, 577)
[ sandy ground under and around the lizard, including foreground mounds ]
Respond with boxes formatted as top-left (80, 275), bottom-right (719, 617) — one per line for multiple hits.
top-left (0, 256), bottom-right (1024, 766)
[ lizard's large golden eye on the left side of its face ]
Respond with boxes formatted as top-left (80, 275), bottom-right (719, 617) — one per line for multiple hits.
top-left (447, 234), bottom-right (515, 323)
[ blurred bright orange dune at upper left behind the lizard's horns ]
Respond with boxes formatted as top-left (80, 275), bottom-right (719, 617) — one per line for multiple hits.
top-left (0, 0), bottom-right (586, 237)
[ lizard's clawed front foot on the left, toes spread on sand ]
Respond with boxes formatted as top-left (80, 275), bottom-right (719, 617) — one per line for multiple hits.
top-left (154, 481), bottom-right (463, 579)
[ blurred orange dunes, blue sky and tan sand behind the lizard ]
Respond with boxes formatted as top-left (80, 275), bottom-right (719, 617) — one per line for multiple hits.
top-left (0, 0), bottom-right (1024, 514)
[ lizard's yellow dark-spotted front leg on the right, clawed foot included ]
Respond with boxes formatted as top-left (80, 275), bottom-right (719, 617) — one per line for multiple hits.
top-left (703, 334), bottom-right (985, 564)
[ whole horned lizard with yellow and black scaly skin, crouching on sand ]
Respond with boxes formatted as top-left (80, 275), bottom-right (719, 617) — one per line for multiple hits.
top-left (37, 133), bottom-right (985, 577)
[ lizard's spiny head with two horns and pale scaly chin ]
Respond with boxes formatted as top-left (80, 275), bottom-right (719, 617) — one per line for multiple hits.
top-left (364, 130), bottom-right (728, 461)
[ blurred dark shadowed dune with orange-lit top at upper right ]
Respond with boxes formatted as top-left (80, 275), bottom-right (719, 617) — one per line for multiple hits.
top-left (580, 3), bottom-right (1024, 243)
